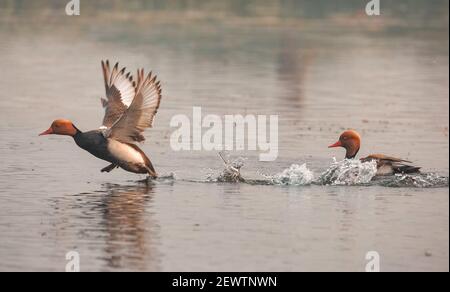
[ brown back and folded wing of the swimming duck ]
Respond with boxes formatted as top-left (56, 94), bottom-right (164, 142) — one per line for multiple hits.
top-left (361, 154), bottom-right (420, 174)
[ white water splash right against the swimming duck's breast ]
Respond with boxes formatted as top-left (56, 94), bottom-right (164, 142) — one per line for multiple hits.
top-left (316, 159), bottom-right (377, 185)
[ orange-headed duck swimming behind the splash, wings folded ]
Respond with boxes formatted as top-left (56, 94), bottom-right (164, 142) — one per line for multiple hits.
top-left (328, 130), bottom-right (420, 175)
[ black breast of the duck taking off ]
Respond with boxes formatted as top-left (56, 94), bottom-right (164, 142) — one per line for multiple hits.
top-left (73, 130), bottom-right (113, 162)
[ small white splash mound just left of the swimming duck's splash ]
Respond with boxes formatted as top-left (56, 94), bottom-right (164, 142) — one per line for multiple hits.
top-left (268, 163), bottom-right (314, 186)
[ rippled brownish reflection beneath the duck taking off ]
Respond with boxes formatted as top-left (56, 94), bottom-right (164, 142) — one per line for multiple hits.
top-left (103, 184), bottom-right (157, 271)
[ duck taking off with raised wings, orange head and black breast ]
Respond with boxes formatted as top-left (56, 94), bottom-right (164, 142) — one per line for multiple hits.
top-left (40, 61), bottom-right (161, 178)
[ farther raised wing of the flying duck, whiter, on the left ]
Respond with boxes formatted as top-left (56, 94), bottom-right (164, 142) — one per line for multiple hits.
top-left (102, 60), bottom-right (136, 128)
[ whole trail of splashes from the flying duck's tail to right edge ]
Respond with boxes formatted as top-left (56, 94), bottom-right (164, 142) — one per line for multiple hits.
top-left (181, 152), bottom-right (449, 188)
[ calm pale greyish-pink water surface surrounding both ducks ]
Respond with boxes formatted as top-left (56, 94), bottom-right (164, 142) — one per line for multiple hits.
top-left (0, 2), bottom-right (449, 271)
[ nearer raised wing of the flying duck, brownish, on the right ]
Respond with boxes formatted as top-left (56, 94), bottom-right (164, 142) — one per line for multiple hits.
top-left (106, 69), bottom-right (161, 143)
